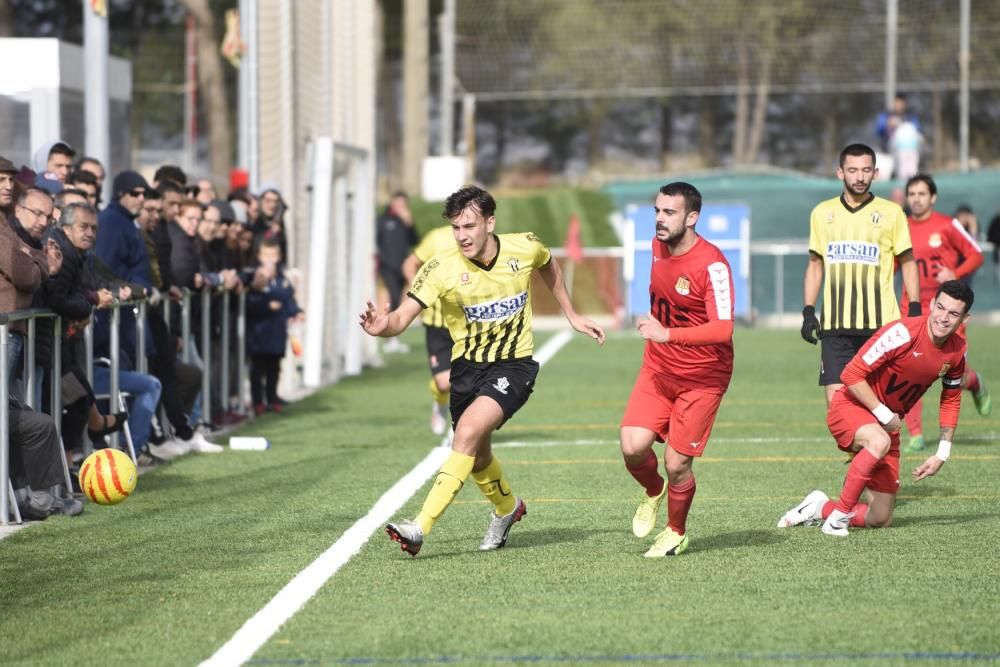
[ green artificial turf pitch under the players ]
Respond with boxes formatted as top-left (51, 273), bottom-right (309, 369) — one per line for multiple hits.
top-left (0, 326), bottom-right (1000, 666)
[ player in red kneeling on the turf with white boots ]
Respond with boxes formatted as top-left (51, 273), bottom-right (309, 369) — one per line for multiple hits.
top-left (778, 280), bottom-right (973, 537)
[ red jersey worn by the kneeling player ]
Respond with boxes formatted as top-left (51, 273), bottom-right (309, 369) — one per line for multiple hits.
top-left (838, 315), bottom-right (966, 427)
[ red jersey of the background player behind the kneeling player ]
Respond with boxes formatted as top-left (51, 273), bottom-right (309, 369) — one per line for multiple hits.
top-left (903, 211), bottom-right (983, 313)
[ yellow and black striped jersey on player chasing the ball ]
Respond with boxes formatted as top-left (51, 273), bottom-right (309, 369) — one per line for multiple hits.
top-left (409, 233), bottom-right (552, 362)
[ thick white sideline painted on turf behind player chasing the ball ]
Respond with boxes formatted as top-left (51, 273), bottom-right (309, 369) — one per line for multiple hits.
top-left (201, 331), bottom-right (573, 667)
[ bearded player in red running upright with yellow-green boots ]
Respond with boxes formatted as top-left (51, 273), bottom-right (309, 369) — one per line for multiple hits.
top-left (621, 182), bottom-right (733, 558)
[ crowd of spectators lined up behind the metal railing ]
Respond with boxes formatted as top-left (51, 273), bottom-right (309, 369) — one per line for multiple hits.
top-left (0, 140), bottom-right (301, 520)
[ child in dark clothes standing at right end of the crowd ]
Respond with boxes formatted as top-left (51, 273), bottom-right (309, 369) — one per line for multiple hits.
top-left (247, 239), bottom-right (302, 415)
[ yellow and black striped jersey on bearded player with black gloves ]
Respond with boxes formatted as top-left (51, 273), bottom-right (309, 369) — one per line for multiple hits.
top-left (809, 195), bottom-right (911, 335)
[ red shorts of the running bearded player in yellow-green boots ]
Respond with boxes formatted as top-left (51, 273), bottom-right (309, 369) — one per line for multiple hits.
top-left (621, 366), bottom-right (722, 456)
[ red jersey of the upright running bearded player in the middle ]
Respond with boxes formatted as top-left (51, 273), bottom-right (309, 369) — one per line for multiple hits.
top-left (643, 236), bottom-right (734, 392)
